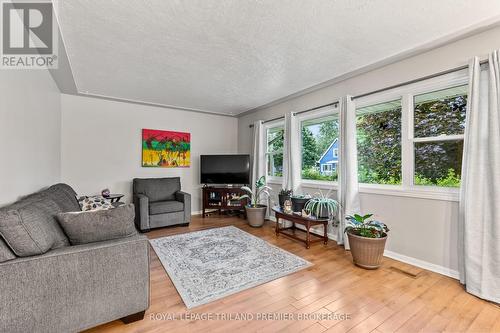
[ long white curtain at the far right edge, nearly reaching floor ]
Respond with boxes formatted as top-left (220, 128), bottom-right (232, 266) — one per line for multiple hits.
top-left (458, 51), bottom-right (500, 303)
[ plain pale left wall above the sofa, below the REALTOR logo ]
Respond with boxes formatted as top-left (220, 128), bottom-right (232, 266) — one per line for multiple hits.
top-left (0, 70), bottom-right (61, 206)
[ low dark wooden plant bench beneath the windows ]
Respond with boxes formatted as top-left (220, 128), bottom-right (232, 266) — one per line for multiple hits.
top-left (272, 207), bottom-right (328, 249)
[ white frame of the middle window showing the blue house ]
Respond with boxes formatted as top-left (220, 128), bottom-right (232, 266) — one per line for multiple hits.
top-left (297, 101), bottom-right (340, 190)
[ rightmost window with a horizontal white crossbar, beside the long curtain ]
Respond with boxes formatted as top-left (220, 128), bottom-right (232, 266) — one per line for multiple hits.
top-left (413, 85), bottom-right (467, 187)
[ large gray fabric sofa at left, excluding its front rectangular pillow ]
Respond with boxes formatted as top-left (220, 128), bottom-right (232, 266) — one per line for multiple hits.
top-left (0, 184), bottom-right (149, 333)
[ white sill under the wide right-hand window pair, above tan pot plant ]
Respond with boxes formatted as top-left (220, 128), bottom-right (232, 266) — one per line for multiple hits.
top-left (359, 184), bottom-right (460, 201)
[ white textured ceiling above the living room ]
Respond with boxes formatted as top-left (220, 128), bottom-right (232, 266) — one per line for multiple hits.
top-left (53, 0), bottom-right (500, 114)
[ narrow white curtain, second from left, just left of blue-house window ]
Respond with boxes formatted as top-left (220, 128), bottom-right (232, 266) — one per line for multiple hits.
top-left (283, 112), bottom-right (301, 193)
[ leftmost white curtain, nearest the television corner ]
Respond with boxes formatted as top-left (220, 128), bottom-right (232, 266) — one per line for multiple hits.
top-left (250, 120), bottom-right (269, 218)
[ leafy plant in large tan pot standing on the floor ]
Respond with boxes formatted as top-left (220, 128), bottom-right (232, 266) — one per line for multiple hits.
top-left (344, 214), bottom-right (389, 269)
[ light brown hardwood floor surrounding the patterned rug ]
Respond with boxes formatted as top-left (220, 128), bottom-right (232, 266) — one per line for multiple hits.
top-left (88, 217), bottom-right (500, 333)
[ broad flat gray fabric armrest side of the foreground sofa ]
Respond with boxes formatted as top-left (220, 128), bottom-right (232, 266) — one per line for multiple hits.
top-left (0, 235), bottom-right (149, 332)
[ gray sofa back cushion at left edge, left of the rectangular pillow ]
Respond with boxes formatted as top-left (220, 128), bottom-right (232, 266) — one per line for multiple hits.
top-left (0, 199), bottom-right (64, 257)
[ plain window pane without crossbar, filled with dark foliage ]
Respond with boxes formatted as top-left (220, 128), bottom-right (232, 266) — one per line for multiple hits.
top-left (356, 100), bottom-right (402, 185)
